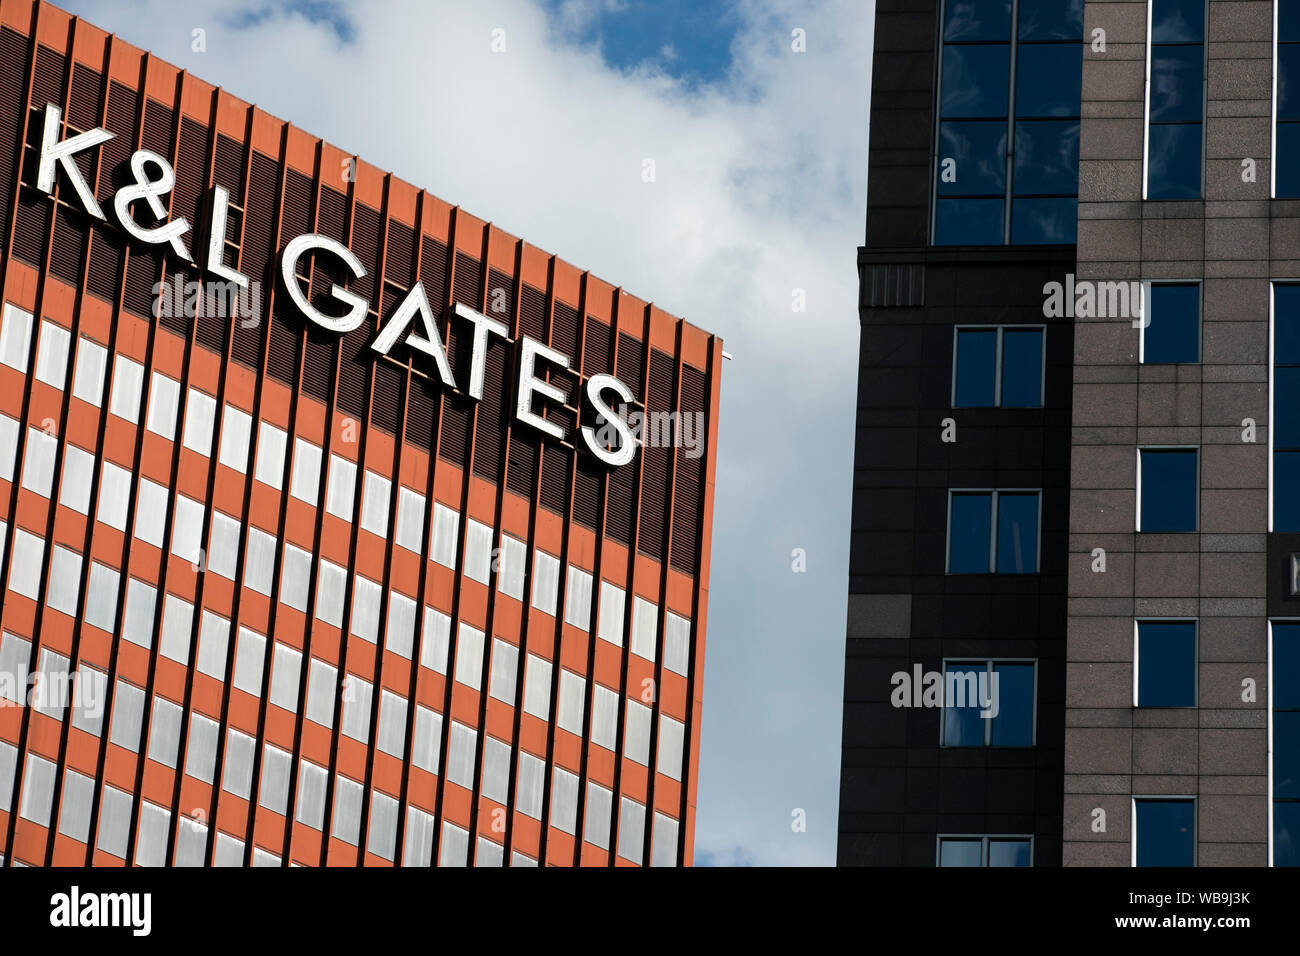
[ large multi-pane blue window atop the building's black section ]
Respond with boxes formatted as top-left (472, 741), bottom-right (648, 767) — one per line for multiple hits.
top-left (935, 0), bottom-right (1083, 246)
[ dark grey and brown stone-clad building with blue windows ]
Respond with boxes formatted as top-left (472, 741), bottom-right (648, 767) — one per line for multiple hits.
top-left (839, 0), bottom-right (1300, 866)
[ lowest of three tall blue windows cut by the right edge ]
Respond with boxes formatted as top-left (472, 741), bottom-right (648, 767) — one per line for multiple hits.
top-left (1269, 620), bottom-right (1300, 866)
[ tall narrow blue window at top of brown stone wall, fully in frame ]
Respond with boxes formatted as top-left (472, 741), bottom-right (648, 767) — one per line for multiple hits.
top-left (1143, 0), bottom-right (1205, 199)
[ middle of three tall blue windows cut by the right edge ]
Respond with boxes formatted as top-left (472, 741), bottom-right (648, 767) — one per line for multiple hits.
top-left (1269, 282), bottom-right (1300, 532)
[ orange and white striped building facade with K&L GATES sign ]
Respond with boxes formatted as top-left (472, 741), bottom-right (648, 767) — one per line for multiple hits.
top-left (0, 0), bottom-right (722, 866)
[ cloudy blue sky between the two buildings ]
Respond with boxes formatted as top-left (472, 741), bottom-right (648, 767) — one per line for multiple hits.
top-left (59, 0), bottom-right (874, 865)
